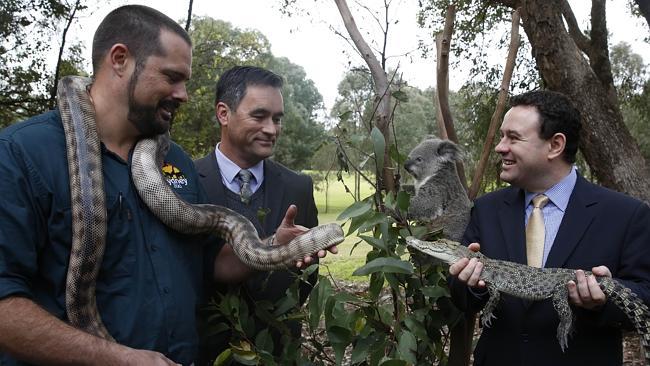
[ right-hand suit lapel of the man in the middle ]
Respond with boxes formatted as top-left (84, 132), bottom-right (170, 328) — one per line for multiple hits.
top-left (263, 159), bottom-right (288, 234)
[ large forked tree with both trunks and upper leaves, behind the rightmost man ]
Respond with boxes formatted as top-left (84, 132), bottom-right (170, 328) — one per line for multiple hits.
top-left (423, 0), bottom-right (650, 202)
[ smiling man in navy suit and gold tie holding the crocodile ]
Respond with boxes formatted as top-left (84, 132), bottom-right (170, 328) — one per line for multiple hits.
top-left (449, 91), bottom-right (650, 366)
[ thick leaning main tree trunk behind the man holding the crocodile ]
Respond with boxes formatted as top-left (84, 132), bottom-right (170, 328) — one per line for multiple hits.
top-left (502, 0), bottom-right (650, 202)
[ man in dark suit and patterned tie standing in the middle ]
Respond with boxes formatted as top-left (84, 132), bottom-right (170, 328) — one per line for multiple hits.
top-left (195, 66), bottom-right (318, 358)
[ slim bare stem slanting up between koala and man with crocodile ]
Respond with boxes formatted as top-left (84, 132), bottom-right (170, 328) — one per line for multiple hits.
top-left (469, 10), bottom-right (519, 200)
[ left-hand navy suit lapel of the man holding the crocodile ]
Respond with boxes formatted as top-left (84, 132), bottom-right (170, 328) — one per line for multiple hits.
top-left (498, 187), bottom-right (526, 263)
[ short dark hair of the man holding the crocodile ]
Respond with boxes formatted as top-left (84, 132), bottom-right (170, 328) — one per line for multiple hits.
top-left (510, 90), bottom-right (582, 164)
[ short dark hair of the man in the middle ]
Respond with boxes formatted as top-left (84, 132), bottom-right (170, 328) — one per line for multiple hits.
top-left (214, 66), bottom-right (283, 111)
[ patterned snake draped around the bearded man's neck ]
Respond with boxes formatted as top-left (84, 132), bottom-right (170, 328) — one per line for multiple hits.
top-left (58, 76), bottom-right (343, 340)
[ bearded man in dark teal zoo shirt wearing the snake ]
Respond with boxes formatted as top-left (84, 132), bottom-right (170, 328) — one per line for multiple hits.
top-left (0, 6), bottom-right (334, 365)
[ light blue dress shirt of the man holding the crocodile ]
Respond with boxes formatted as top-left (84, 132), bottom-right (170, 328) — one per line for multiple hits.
top-left (524, 167), bottom-right (577, 267)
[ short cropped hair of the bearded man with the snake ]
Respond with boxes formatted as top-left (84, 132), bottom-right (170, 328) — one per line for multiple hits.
top-left (92, 5), bottom-right (192, 73)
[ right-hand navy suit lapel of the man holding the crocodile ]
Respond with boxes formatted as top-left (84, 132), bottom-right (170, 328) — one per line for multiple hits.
top-left (546, 175), bottom-right (597, 268)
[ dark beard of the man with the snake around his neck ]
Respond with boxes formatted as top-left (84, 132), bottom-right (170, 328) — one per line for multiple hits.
top-left (127, 67), bottom-right (180, 137)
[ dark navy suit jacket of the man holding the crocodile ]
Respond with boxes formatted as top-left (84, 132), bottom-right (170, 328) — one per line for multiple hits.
top-left (451, 176), bottom-right (650, 366)
